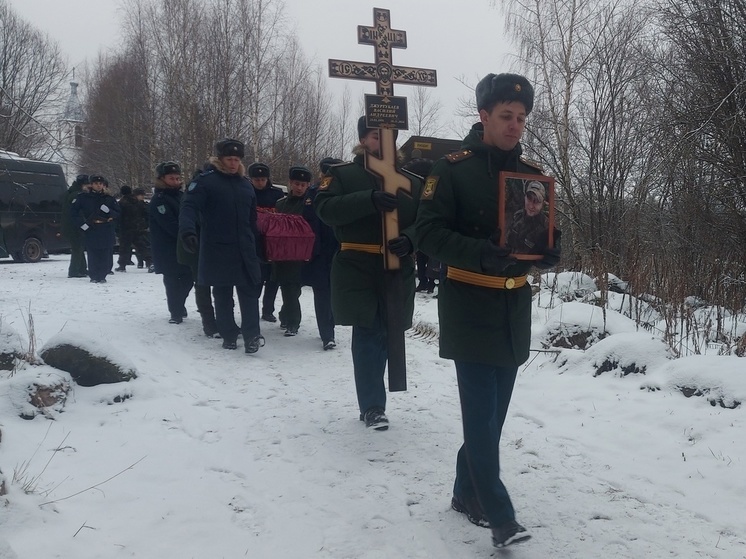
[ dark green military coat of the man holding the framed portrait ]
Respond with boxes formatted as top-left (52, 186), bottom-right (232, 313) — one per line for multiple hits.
top-left (417, 124), bottom-right (541, 367)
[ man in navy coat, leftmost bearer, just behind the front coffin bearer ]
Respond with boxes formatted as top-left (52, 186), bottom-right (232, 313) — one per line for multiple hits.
top-left (148, 161), bottom-right (193, 324)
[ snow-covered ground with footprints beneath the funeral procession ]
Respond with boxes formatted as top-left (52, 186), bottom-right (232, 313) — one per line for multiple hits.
top-left (0, 256), bottom-right (746, 559)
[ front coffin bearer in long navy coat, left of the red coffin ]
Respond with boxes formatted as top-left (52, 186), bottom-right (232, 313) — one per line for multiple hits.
top-left (179, 138), bottom-right (264, 353)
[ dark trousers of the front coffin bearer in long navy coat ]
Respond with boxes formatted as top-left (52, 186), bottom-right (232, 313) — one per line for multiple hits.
top-left (212, 284), bottom-right (261, 343)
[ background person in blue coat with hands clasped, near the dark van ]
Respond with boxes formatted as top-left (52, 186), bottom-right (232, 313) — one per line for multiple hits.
top-left (71, 175), bottom-right (119, 283)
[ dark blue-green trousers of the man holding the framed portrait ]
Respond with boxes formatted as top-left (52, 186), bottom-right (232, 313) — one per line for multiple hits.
top-left (453, 361), bottom-right (518, 526)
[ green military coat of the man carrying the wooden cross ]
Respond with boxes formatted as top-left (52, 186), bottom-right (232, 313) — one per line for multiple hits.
top-left (314, 155), bottom-right (422, 328)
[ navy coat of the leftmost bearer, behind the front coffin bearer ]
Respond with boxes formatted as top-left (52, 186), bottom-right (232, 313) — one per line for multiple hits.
top-left (148, 182), bottom-right (190, 276)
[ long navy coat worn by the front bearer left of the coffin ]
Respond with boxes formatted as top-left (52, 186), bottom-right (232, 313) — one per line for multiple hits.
top-left (179, 158), bottom-right (262, 285)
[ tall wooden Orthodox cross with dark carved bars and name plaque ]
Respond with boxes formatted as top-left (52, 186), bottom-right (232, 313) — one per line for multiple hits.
top-left (329, 8), bottom-right (437, 392)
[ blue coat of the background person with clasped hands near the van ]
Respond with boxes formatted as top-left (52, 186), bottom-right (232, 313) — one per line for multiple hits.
top-left (70, 190), bottom-right (119, 250)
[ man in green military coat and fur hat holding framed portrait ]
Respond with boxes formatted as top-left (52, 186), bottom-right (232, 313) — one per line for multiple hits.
top-left (417, 74), bottom-right (560, 547)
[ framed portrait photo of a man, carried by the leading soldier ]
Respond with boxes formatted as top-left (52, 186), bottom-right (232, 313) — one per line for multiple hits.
top-left (498, 171), bottom-right (554, 260)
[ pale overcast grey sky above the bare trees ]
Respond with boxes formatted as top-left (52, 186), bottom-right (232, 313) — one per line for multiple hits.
top-left (6, 0), bottom-right (512, 137)
